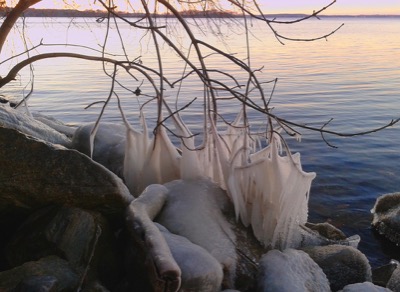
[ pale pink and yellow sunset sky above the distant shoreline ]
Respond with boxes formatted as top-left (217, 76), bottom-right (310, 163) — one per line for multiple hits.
top-left (7, 0), bottom-right (400, 15)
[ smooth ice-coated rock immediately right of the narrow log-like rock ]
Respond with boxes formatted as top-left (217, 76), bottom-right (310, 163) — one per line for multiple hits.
top-left (157, 224), bottom-right (224, 292)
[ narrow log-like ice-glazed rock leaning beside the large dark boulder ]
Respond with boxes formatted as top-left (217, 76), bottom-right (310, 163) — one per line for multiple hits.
top-left (125, 185), bottom-right (181, 291)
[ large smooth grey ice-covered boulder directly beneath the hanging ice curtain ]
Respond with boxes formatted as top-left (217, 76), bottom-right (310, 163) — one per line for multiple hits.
top-left (156, 179), bottom-right (237, 288)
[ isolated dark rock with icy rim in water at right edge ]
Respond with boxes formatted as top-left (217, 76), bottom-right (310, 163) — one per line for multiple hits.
top-left (371, 193), bottom-right (400, 245)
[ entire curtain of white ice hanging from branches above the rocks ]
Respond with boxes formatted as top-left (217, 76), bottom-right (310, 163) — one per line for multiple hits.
top-left (114, 102), bottom-right (315, 249)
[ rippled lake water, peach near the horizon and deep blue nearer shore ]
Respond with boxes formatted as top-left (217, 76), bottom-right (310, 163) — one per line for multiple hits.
top-left (0, 17), bottom-right (400, 267)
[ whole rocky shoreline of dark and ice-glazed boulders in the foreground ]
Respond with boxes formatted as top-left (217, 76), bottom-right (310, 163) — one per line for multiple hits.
top-left (0, 104), bottom-right (400, 291)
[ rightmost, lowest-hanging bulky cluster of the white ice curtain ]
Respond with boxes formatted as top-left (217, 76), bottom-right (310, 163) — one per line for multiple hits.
top-left (228, 134), bottom-right (315, 248)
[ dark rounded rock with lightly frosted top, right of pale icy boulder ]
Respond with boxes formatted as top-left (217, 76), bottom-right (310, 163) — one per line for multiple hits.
top-left (303, 245), bottom-right (372, 291)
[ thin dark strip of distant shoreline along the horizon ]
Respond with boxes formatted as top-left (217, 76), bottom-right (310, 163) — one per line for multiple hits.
top-left (0, 8), bottom-right (400, 19)
